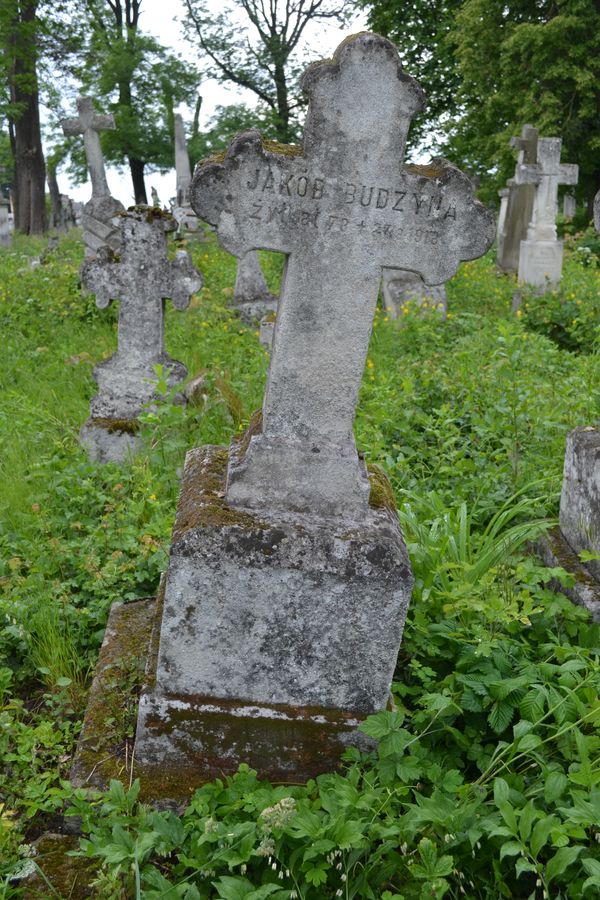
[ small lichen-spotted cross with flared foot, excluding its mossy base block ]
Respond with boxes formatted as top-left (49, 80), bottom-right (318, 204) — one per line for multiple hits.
top-left (81, 207), bottom-right (202, 418)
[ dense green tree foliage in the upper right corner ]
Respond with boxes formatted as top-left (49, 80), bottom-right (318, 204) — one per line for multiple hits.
top-left (363, 0), bottom-right (600, 202)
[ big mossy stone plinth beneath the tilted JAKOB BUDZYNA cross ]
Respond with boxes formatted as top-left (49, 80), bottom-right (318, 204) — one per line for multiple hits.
top-left (135, 447), bottom-right (413, 780)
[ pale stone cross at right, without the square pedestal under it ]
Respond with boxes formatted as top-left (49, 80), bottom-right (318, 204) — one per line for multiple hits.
top-left (515, 138), bottom-right (579, 241)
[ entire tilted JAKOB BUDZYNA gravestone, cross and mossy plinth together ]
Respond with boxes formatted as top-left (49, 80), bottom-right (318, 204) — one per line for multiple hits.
top-left (135, 34), bottom-right (494, 784)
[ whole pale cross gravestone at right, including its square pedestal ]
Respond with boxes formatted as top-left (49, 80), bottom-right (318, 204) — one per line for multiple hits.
top-left (516, 138), bottom-right (579, 288)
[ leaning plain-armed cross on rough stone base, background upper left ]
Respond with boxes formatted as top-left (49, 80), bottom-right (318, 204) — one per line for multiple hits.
top-left (61, 97), bottom-right (125, 257)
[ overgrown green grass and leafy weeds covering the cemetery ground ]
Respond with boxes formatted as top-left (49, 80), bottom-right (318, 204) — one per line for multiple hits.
top-left (0, 225), bottom-right (600, 900)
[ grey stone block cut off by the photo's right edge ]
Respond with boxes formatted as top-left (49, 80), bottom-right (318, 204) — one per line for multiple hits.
top-left (559, 426), bottom-right (600, 581)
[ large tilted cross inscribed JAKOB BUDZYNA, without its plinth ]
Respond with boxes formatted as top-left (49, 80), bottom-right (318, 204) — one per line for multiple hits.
top-left (192, 34), bottom-right (494, 519)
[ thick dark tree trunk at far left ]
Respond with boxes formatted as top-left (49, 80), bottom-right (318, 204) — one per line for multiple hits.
top-left (9, 0), bottom-right (46, 234)
